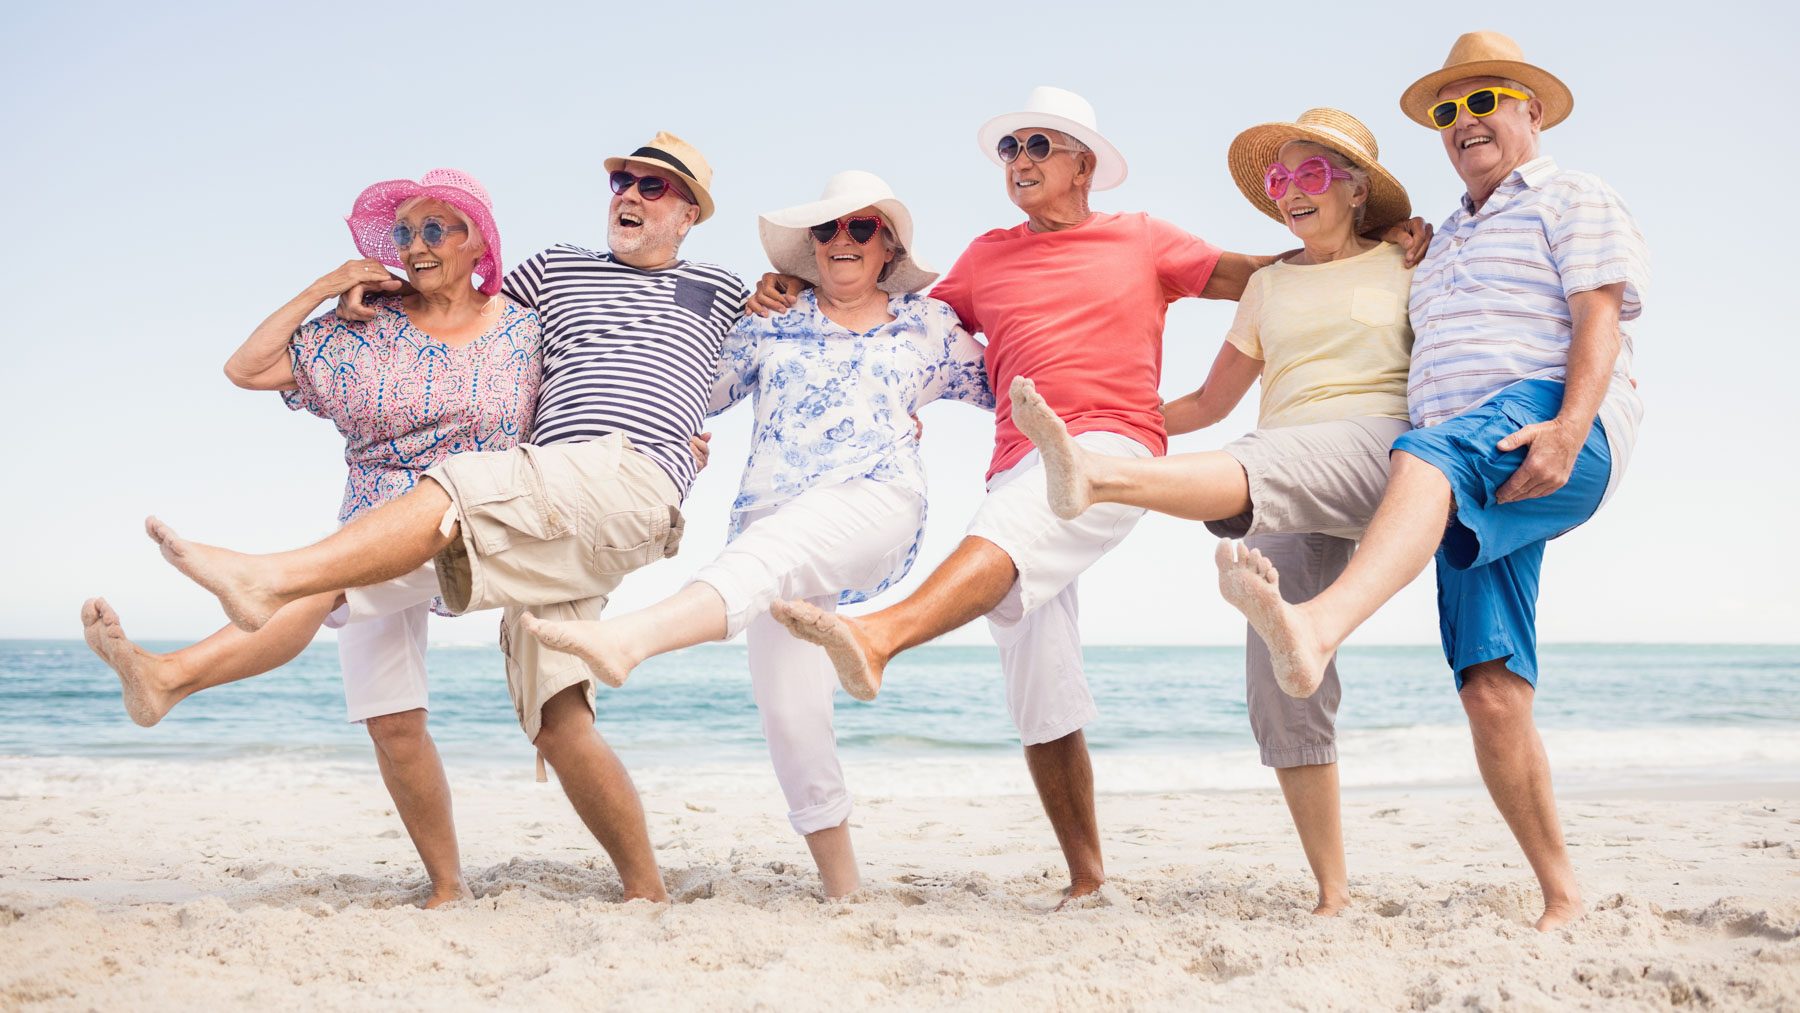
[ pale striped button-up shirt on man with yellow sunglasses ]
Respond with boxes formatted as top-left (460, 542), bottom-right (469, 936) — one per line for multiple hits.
top-left (1406, 157), bottom-right (1649, 497)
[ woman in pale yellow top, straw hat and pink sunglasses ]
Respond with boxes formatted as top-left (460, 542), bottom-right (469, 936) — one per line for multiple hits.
top-left (1012, 110), bottom-right (1413, 914)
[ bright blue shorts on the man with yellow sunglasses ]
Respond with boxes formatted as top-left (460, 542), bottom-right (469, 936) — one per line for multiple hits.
top-left (1393, 380), bottom-right (1613, 691)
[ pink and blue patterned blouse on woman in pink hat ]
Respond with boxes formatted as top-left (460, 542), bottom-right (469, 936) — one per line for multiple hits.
top-left (281, 297), bottom-right (544, 522)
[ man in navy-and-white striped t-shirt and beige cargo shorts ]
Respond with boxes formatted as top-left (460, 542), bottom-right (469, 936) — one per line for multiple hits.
top-left (149, 133), bottom-right (749, 901)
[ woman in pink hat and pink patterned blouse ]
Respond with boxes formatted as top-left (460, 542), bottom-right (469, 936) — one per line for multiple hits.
top-left (81, 169), bottom-right (542, 907)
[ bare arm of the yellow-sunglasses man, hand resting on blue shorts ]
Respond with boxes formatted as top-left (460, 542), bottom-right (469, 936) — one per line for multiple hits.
top-left (1494, 281), bottom-right (1625, 504)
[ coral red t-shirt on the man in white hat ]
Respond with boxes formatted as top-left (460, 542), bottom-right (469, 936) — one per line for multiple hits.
top-left (931, 212), bottom-right (1219, 479)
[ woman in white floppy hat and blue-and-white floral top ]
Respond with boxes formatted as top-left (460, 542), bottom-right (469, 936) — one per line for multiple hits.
top-left (526, 171), bottom-right (994, 896)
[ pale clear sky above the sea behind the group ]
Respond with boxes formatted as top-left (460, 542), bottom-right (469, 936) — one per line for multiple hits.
top-left (0, 2), bottom-right (1800, 642)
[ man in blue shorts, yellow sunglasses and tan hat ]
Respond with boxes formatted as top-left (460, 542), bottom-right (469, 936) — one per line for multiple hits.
top-left (1219, 32), bottom-right (1647, 930)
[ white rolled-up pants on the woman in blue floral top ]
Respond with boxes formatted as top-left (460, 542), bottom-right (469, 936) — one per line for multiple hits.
top-left (693, 479), bottom-right (925, 833)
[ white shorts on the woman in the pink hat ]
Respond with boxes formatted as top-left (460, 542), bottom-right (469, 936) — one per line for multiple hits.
top-left (326, 563), bottom-right (437, 723)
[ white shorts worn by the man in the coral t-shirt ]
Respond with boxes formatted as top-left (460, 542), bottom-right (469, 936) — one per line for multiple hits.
top-left (968, 432), bottom-right (1150, 745)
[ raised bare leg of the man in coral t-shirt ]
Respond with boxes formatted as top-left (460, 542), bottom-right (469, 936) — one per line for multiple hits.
top-left (769, 534), bottom-right (1019, 700)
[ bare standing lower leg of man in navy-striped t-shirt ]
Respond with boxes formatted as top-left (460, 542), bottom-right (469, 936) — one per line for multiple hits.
top-left (536, 686), bottom-right (668, 901)
